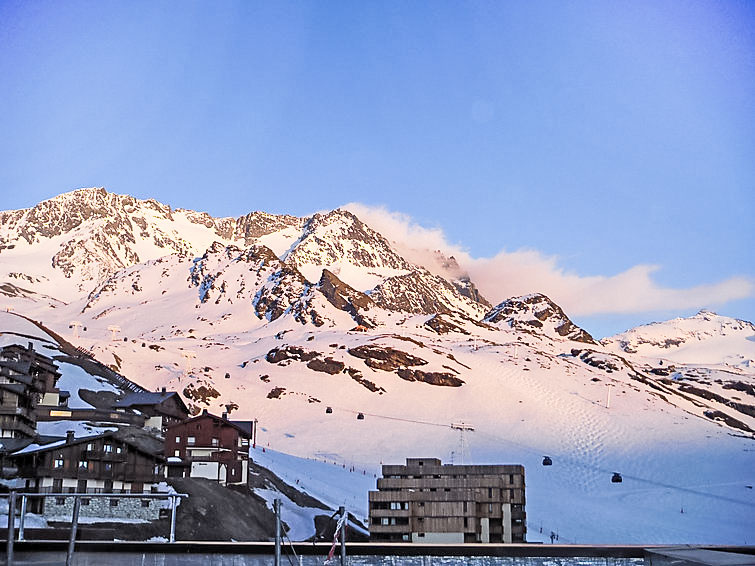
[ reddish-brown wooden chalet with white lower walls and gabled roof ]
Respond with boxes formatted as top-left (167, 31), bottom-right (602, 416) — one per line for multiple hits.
top-left (164, 411), bottom-right (252, 484)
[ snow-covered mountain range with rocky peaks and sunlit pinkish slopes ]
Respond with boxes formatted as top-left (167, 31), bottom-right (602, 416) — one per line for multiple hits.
top-left (0, 189), bottom-right (755, 544)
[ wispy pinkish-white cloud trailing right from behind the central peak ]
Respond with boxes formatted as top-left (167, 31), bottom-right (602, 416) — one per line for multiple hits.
top-left (344, 203), bottom-right (755, 316)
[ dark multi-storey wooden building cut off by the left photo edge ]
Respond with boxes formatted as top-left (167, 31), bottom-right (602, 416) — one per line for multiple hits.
top-left (0, 343), bottom-right (60, 438)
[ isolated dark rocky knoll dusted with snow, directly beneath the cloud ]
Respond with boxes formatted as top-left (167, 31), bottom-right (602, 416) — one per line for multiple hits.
top-left (484, 293), bottom-right (595, 344)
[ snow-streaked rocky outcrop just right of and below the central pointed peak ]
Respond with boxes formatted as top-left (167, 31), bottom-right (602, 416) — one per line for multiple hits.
top-left (370, 269), bottom-right (484, 317)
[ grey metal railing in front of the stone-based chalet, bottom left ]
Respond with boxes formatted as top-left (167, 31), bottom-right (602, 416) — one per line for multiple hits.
top-left (6, 490), bottom-right (189, 566)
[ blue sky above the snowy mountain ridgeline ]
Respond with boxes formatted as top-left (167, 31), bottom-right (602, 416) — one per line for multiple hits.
top-left (0, 1), bottom-right (755, 335)
